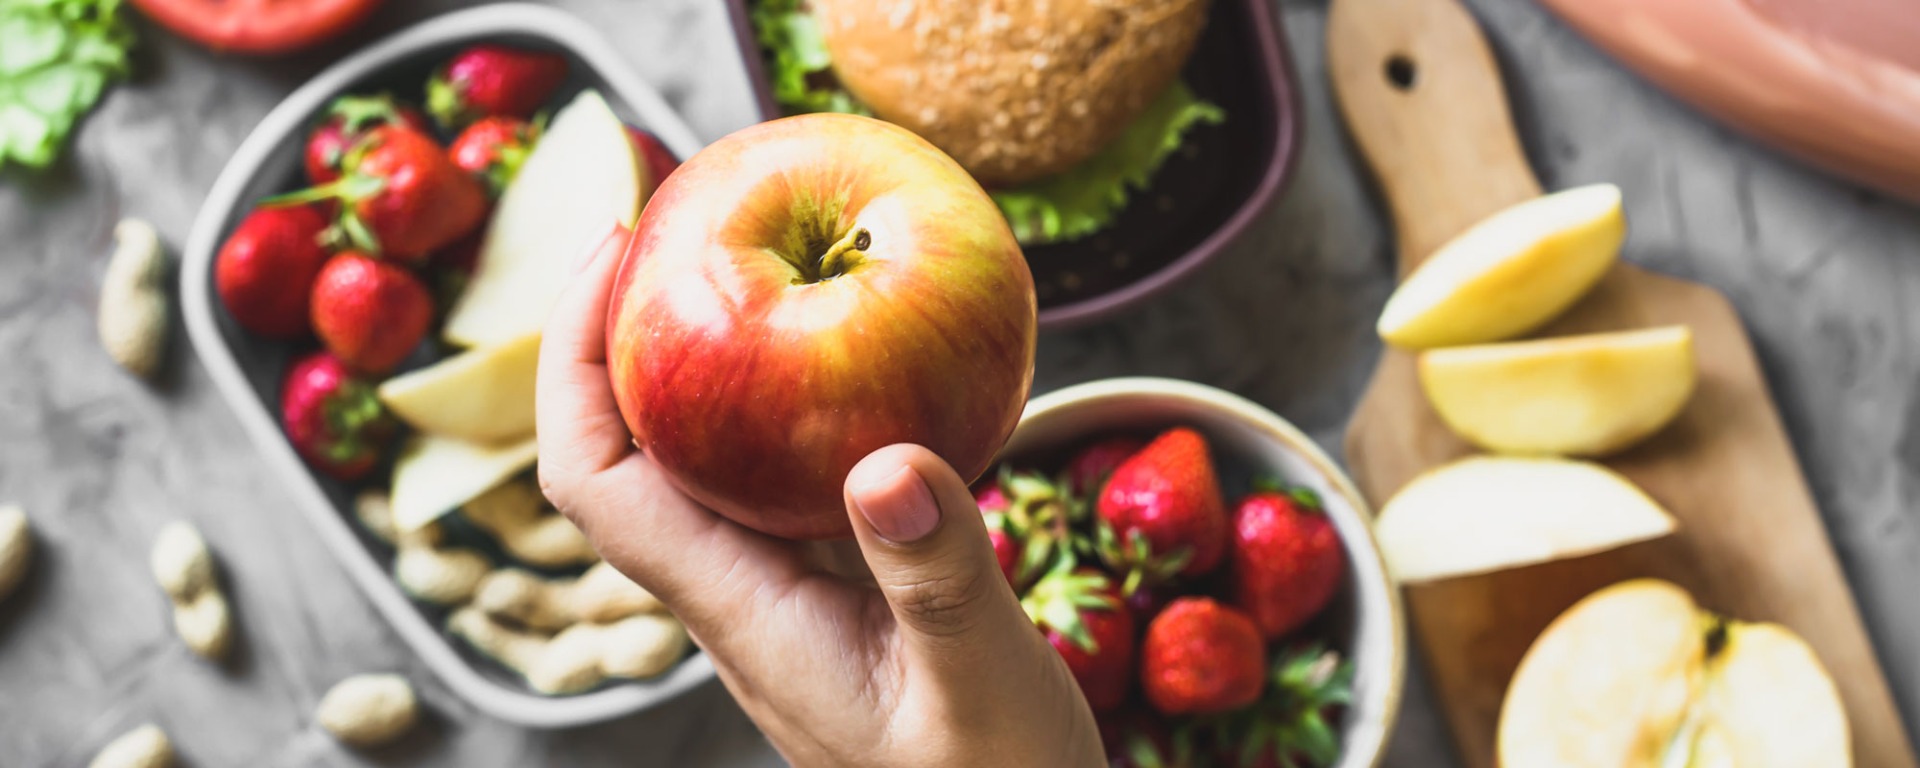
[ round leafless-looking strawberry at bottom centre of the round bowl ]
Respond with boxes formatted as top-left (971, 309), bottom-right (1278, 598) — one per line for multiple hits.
top-left (1140, 597), bottom-right (1267, 714)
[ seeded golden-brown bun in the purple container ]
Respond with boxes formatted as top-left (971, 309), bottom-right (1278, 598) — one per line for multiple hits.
top-left (812, 0), bottom-right (1208, 188)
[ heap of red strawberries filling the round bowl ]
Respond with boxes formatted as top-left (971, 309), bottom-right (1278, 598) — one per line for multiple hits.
top-left (973, 426), bottom-right (1354, 768)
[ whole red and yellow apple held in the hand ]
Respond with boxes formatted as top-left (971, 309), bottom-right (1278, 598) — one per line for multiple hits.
top-left (607, 113), bottom-right (1035, 540)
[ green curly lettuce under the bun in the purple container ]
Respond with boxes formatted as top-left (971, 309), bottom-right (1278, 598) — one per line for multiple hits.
top-left (751, 0), bottom-right (1227, 246)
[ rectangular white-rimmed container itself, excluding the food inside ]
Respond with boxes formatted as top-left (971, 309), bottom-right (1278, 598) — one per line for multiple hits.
top-left (180, 4), bottom-right (714, 728)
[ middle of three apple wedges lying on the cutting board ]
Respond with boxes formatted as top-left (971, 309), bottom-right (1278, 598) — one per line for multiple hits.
top-left (1419, 324), bottom-right (1695, 455)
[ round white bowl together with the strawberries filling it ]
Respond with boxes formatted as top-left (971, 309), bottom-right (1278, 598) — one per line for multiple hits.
top-left (973, 378), bottom-right (1405, 768)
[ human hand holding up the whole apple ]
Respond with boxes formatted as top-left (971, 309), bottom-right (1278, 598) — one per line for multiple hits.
top-left (538, 230), bottom-right (1106, 766)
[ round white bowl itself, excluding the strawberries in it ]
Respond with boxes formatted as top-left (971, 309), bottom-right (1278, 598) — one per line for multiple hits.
top-left (1000, 378), bottom-right (1405, 768)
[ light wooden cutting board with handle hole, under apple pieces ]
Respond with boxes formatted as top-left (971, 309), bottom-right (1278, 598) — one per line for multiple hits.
top-left (1327, 0), bottom-right (1916, 768)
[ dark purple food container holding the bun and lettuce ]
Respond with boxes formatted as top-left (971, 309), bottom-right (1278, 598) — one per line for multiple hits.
top-left (728, 0), bottom-right (1300, 330)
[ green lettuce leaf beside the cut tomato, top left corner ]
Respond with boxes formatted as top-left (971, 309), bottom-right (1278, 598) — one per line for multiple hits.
top-left (0, 0), bottom-right (132, 169)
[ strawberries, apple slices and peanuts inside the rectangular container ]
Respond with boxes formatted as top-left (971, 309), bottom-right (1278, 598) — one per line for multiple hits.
top-left (213, 42), bottom-right (689, 693)
